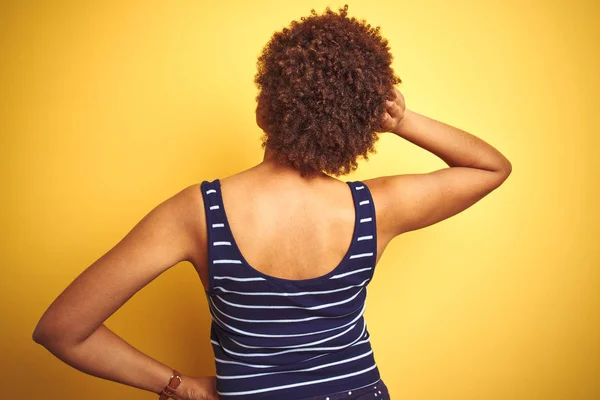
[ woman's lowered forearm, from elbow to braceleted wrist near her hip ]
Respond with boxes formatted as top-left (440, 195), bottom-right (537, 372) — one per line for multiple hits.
top-left (34, 324), bottom-right (173, 397)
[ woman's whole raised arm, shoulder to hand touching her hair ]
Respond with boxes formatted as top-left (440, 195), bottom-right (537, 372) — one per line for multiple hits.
top-left (364, 89), bottom-right (512, 240)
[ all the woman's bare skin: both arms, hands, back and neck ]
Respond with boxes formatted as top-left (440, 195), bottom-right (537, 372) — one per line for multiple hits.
top-left (33, 89), bottom-right (512, 400)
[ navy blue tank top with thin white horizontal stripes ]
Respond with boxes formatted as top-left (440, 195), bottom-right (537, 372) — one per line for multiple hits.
top-left (201, 179), bottom-right (380, 400)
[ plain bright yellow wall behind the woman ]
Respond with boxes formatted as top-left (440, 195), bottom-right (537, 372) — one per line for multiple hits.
top-left (0, 0), bottom-right (600, 400)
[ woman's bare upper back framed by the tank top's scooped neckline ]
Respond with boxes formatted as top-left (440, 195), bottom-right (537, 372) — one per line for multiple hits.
top-left (193, 169), bottom-right (391, 289)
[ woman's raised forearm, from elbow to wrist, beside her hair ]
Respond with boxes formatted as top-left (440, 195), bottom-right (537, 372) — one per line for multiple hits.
top-left (393, 109), bottom-right (511, 171)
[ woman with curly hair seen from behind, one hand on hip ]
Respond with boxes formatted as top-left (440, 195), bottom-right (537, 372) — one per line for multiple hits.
top-left (33, 6), bottom-right (511, 400)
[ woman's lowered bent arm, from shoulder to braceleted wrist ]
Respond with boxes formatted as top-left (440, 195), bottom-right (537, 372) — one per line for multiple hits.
top-left (33, 185), bottom-right (202, 393)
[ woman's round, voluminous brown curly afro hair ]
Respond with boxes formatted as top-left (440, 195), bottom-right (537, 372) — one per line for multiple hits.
top-left (254, 4), bottom-right (402, 177)
